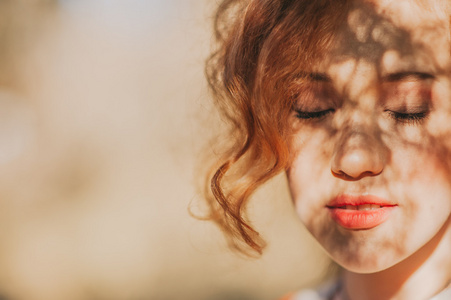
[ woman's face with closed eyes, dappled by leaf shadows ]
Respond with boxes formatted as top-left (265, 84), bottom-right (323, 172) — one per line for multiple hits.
top-left (287, 0), bottom-right (451, 273)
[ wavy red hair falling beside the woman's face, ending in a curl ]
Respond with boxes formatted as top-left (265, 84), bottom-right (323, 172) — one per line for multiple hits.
top-left (206, 0), bottom-right (347, 254)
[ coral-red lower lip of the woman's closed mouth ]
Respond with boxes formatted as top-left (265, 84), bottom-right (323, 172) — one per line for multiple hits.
top-left (328, 206), bottom-right (395, 230)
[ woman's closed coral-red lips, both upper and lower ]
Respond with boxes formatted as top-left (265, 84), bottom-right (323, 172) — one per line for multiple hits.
top-left (326, 194), bottom-right (397, 230)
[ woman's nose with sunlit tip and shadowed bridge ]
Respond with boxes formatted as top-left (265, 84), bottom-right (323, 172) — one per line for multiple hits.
top-left (331, 130), bottom-right (387, 181)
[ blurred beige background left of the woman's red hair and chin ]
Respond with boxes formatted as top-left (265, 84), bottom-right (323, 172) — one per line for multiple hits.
top-left (0, 0), bottom-right (328, 300)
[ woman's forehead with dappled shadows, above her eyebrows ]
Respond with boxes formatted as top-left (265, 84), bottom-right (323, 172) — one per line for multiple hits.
top-left (320, 0), bottom-right (450, 72)
